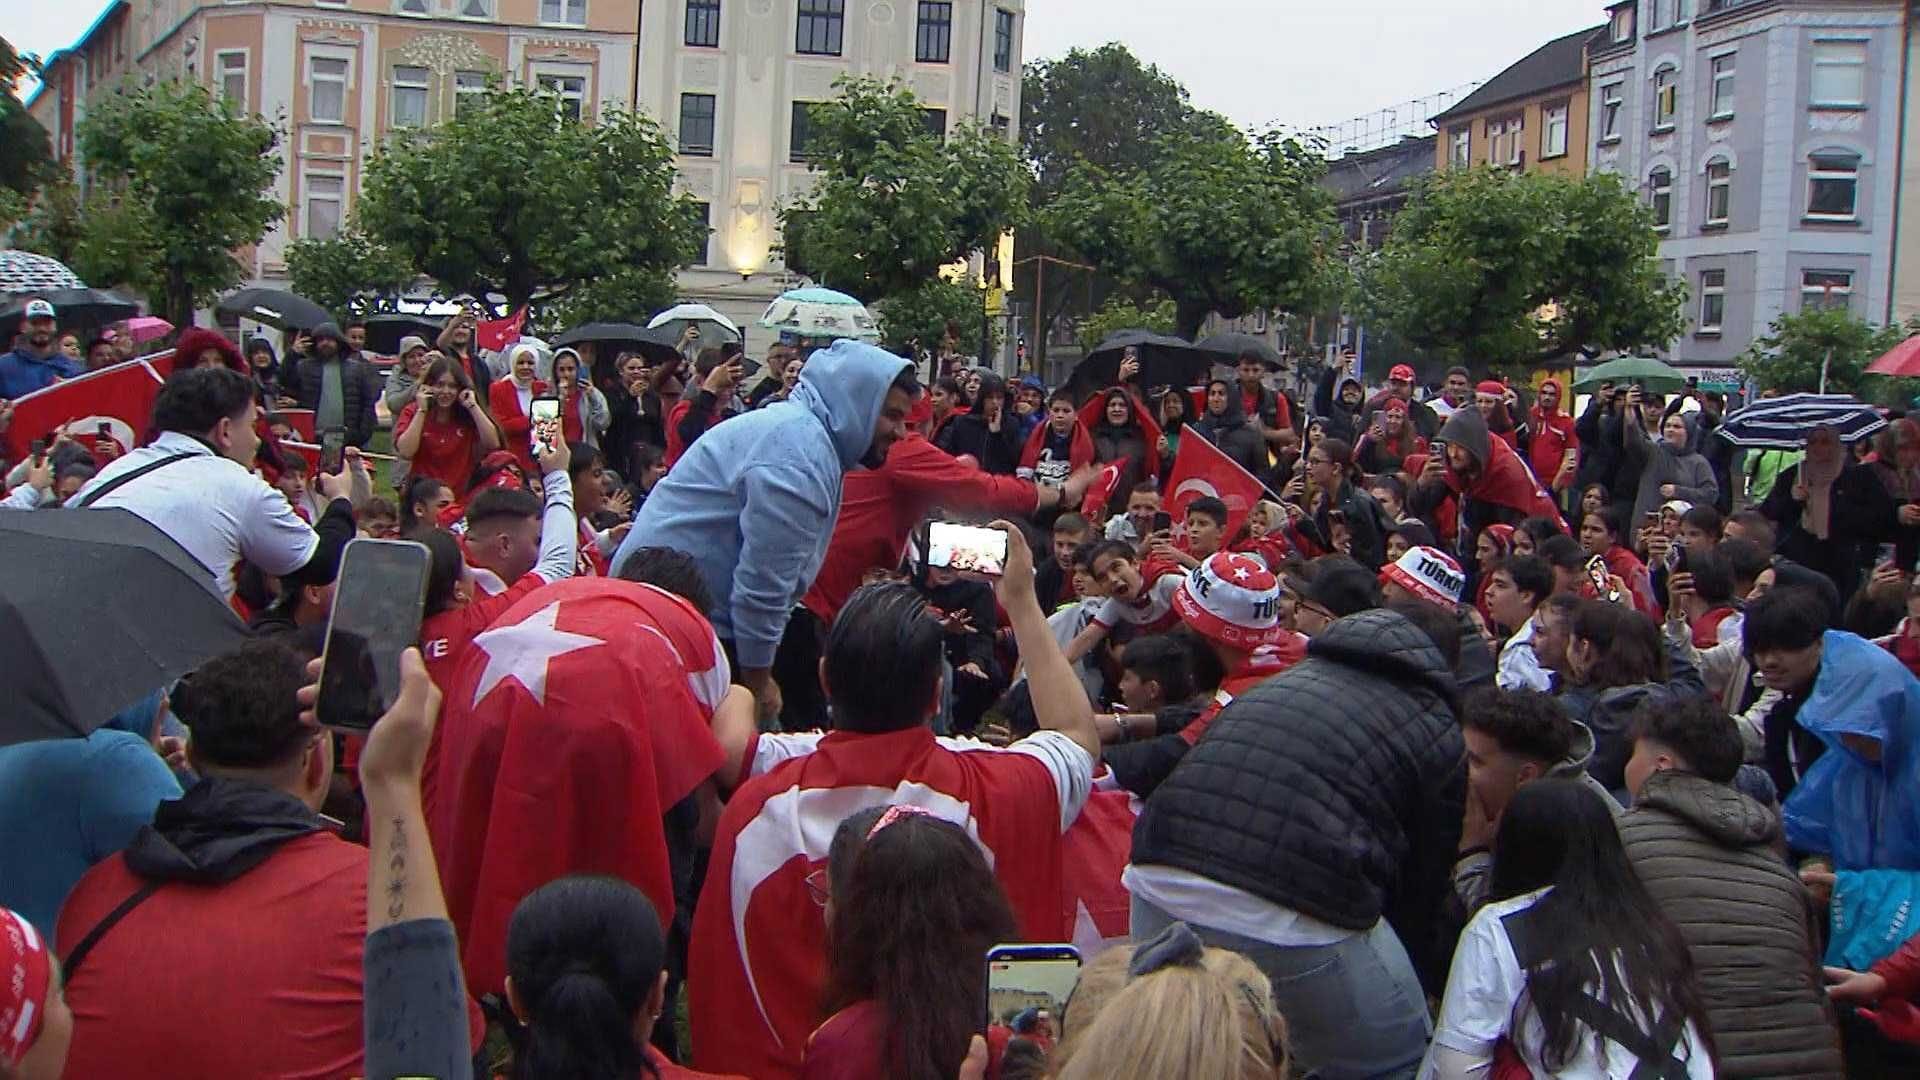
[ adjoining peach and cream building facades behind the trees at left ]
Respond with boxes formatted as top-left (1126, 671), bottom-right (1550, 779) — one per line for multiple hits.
top-left (29, 0), bottom-right (1025, 332)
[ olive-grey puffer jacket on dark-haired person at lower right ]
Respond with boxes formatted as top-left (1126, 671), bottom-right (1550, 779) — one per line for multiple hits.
top-left (1620, 771), bottom-right (1841, 1078)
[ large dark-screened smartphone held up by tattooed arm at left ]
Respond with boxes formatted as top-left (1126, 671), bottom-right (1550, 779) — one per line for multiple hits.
top-left (315, 540), bottom-right (434, 732)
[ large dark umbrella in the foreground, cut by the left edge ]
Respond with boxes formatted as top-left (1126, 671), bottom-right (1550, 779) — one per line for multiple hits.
top-left (0, 509), bottom-right (246, 746)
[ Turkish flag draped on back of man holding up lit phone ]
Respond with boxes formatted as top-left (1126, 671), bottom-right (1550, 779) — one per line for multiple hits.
top-left (687, 726), bottom-right (1079, 1080)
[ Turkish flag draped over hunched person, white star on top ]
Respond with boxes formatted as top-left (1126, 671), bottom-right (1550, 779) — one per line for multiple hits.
top-left (426, 578), bottom-right (730, 995)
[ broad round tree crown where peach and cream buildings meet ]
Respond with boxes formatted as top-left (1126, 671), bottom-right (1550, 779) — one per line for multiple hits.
top-left (357, 86), bottom-right (705, 317)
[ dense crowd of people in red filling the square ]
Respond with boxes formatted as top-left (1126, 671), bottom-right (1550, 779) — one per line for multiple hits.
top-left (0, 288), bottom-right (1920, 1080)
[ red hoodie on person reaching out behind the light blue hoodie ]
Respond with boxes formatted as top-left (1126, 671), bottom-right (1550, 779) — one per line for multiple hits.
top-left (801, 434), bottom-right (1044, 623)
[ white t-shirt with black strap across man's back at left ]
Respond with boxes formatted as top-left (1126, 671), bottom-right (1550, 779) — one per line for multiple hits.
top-left (73, 432), bottom-right (321, 598)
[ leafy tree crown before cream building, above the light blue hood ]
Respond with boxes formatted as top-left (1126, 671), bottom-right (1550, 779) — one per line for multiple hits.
top-left (780, 79), bottom-right (1031, 304)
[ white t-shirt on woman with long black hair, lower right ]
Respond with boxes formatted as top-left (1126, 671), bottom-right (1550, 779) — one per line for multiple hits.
top-left (1421, 888), bottom-right (1713, 1080)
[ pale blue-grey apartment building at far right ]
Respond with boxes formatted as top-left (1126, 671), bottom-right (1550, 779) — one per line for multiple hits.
top-left (1588, 0), bottom-right (1907, 367)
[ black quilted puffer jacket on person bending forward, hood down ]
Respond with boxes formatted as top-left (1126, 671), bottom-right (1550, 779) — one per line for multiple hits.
top-left (1133, 611), bottom-right (1467, 986)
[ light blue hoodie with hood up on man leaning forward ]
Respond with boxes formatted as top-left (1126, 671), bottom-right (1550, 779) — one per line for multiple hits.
top-left (612, 340), bottom-right (906, 669)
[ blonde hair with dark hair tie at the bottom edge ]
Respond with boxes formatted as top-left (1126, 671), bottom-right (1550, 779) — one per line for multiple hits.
top-left (1048, 949), bottom-right (1288, 1080)
